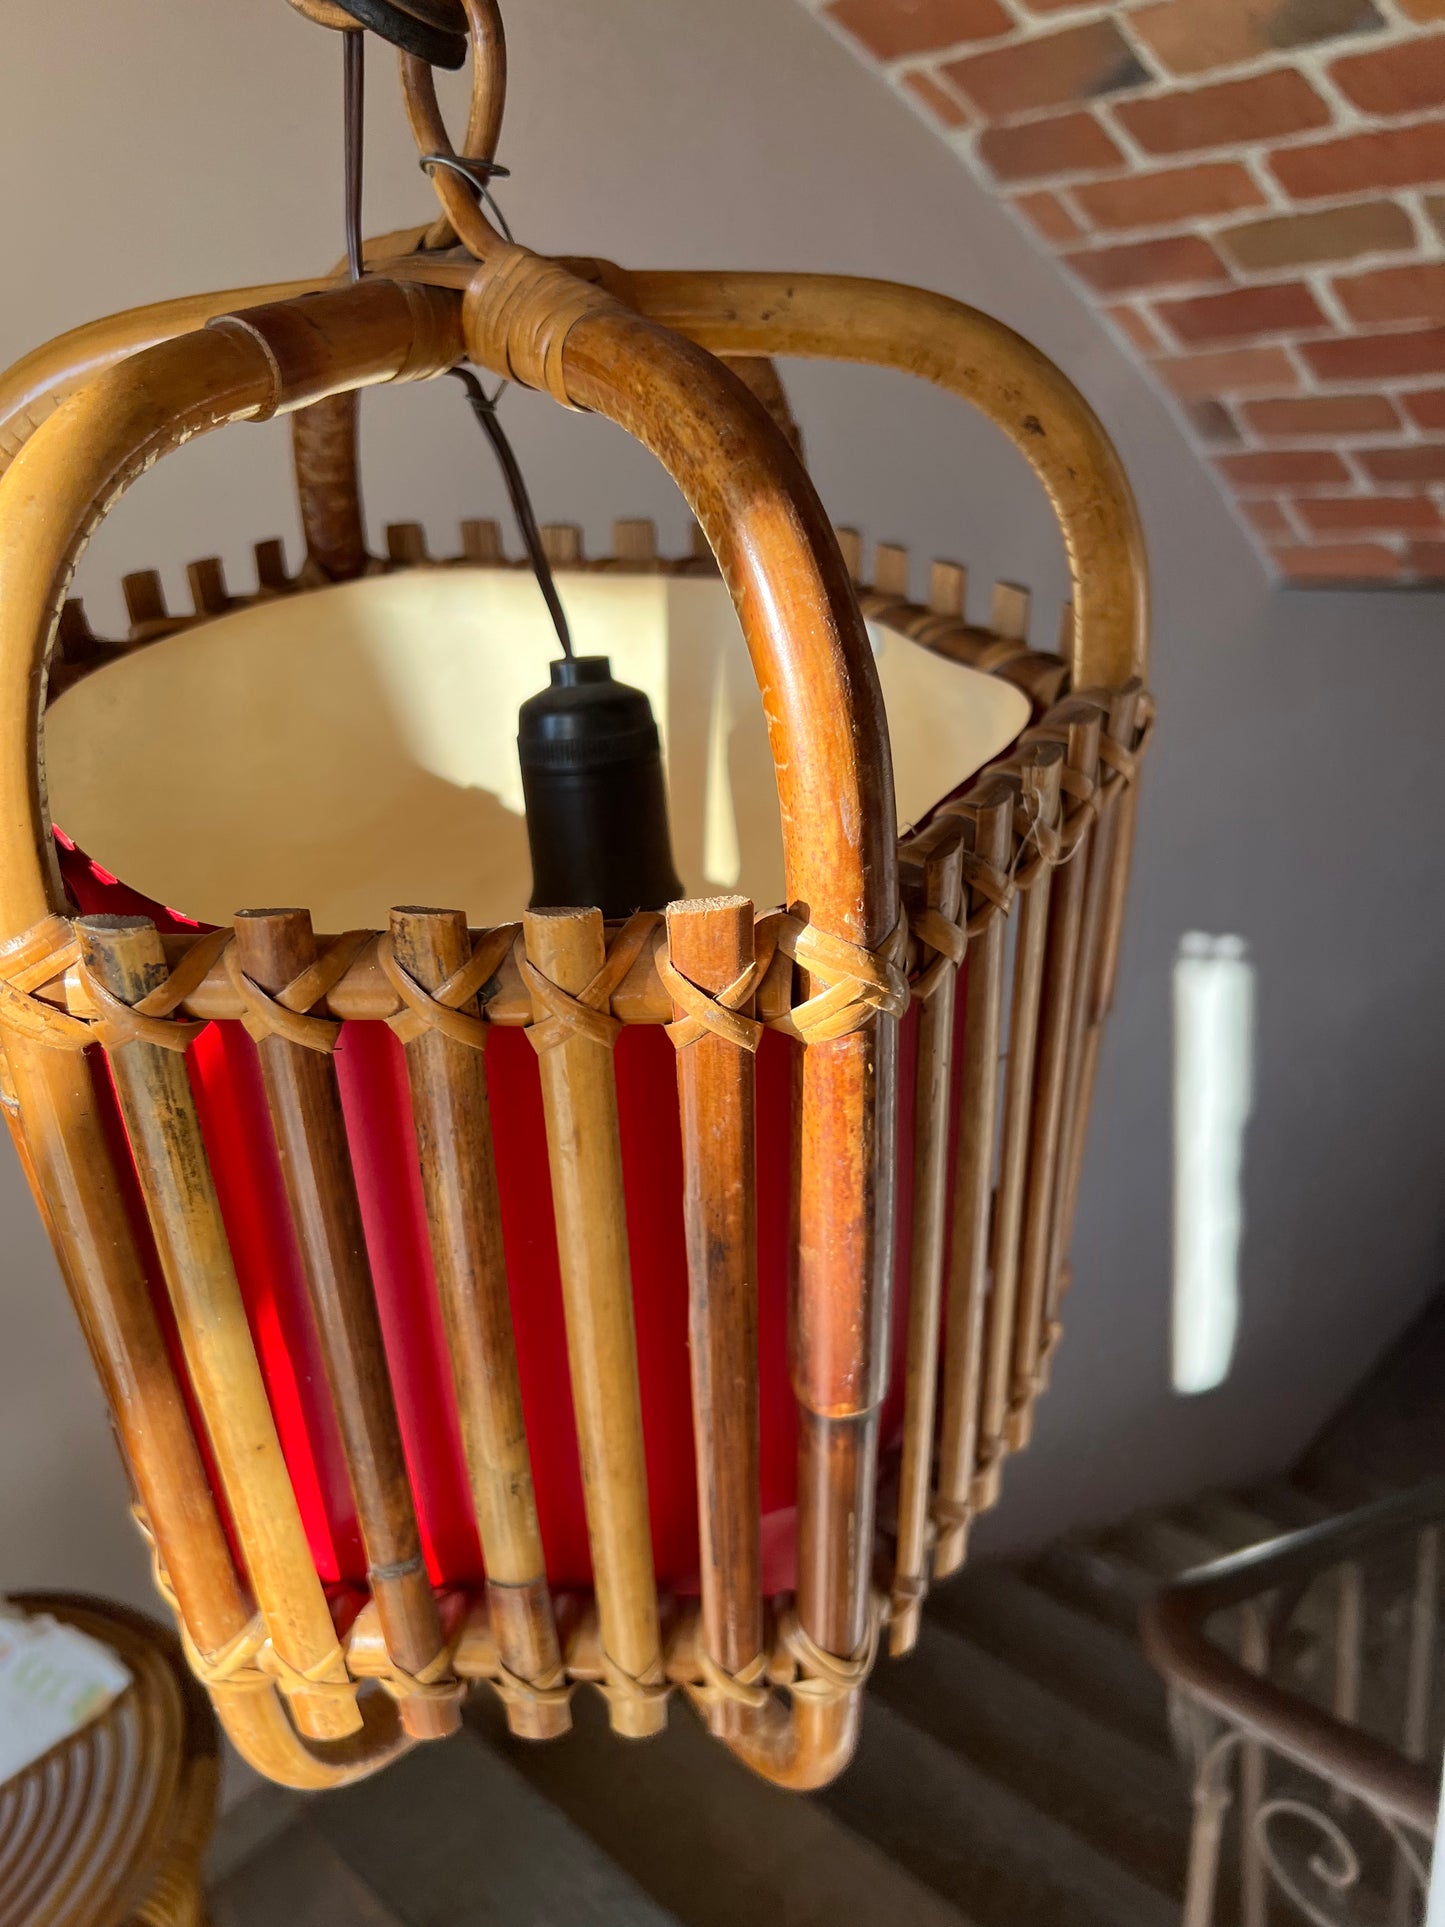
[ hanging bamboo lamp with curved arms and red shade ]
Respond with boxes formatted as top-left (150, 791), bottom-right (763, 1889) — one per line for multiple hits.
top-left (0, 0), bottom-right (1150, 1788)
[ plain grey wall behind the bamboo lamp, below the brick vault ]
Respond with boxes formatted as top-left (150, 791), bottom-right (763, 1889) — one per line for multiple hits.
top-left (0, 0), bottom-right (1445, 1626)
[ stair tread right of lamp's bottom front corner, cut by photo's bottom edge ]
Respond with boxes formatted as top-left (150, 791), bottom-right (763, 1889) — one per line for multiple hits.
top-left (819, 1696), bottom-right (1179, 1927)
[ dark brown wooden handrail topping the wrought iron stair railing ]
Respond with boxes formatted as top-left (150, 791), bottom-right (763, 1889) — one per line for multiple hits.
top-left (1141, 1480), bottom-right (1445, 1835)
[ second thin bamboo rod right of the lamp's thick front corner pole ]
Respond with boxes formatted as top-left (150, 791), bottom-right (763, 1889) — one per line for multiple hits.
top-left (933, 777), bottom-right (1015, 1578)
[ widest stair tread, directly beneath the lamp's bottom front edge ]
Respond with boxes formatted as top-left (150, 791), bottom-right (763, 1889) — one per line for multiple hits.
top-left (476, 1694), bottom-right (979, 1927)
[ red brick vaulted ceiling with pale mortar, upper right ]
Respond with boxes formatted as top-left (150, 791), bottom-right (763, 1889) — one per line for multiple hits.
top-left (803, 0), bottom-right (1445, 586)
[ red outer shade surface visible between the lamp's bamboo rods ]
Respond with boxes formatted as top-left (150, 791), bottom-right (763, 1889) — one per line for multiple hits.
top-left (56, 832), bottom-right (963, 1594)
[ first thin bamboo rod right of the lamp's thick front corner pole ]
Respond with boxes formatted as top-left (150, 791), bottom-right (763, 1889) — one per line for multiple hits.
top-left (888, 828), bottom-right (963, 1655)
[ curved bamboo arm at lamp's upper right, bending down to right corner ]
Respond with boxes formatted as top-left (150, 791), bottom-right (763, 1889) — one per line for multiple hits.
top-left (618, 272), bottom-right (1148, 688)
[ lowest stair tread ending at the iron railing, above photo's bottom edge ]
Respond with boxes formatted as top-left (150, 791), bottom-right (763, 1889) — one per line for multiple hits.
top-left (875, 1623), bottom-right (1191, 1892)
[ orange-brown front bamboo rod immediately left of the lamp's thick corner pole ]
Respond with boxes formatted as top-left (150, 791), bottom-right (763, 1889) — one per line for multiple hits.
top-left (667, 896), bottom-right (763, 1738)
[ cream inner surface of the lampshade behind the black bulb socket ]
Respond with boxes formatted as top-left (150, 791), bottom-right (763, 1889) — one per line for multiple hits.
top-left (46, 568), bottom-right (1029, 931)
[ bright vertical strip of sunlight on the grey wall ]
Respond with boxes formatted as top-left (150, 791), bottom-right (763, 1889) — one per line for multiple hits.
top-left (1173, 931), bottom-right (1254, 1393)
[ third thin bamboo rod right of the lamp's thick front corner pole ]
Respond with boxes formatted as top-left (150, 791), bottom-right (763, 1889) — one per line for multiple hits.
top-left (973, 744), bottom-right (1064, 1511)
